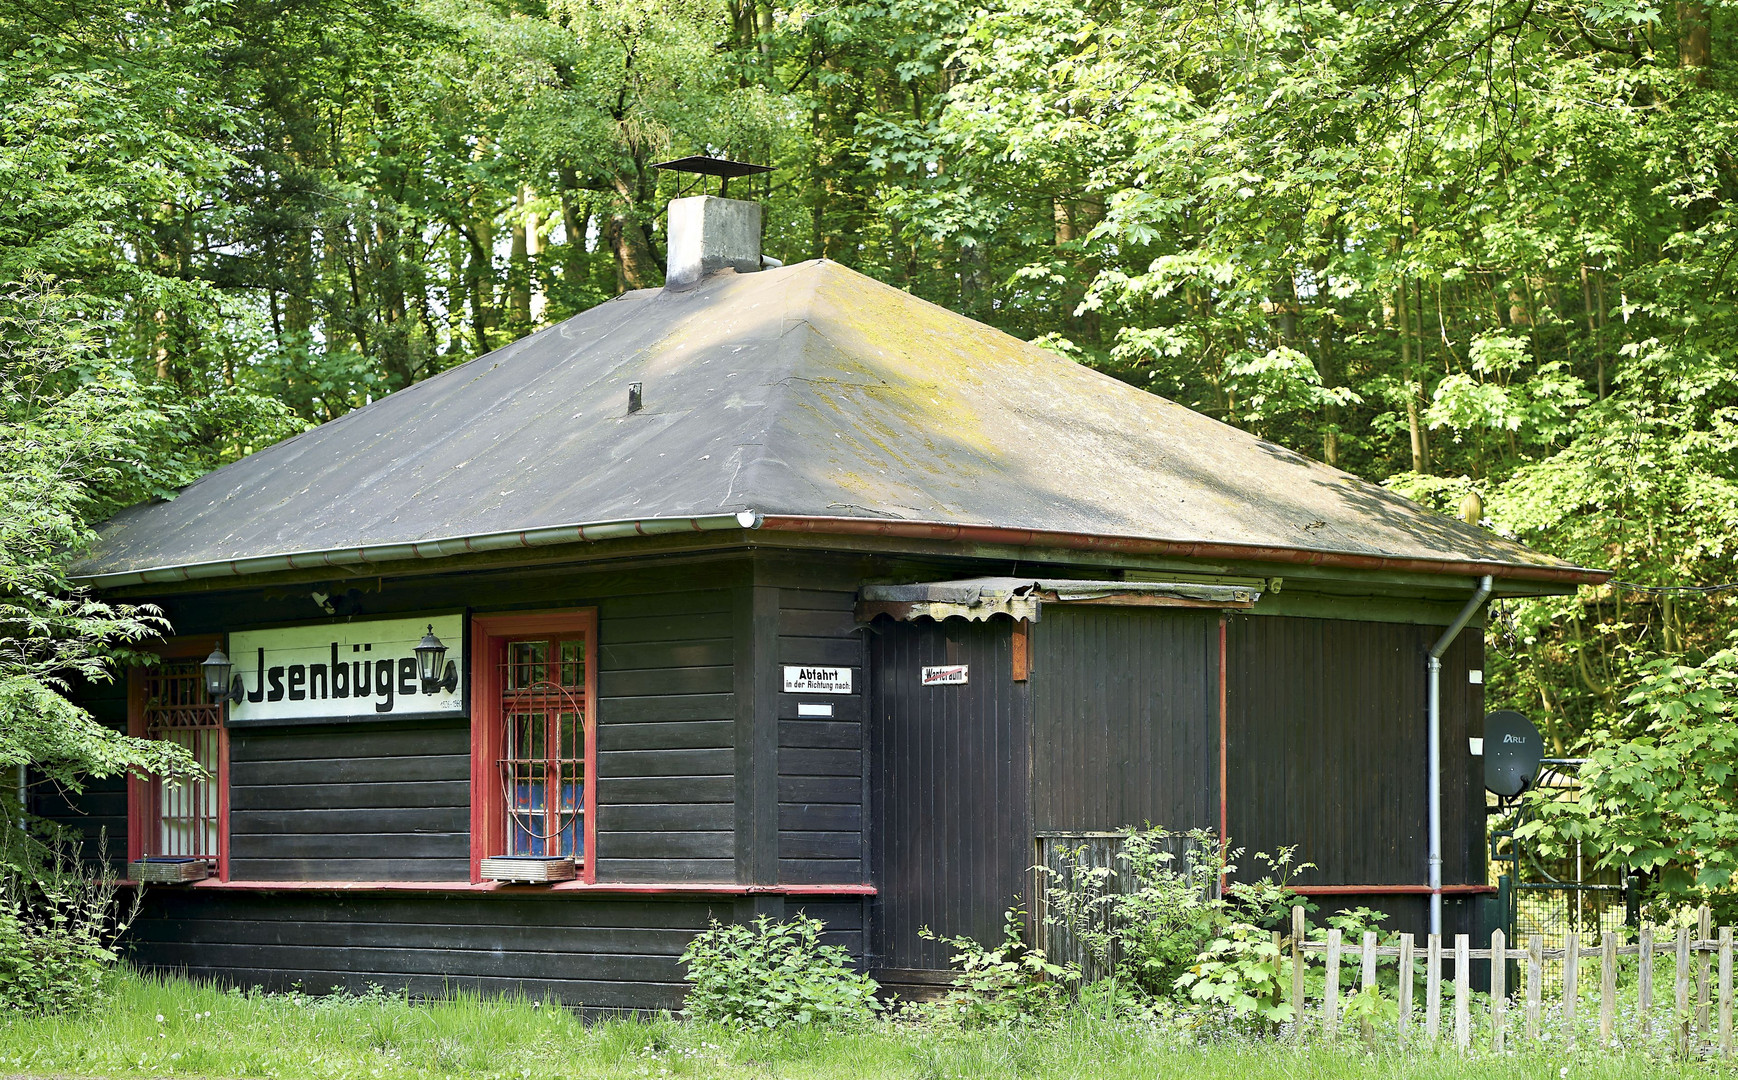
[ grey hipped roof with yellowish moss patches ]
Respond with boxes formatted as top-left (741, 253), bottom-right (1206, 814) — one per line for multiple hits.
top-left (78, 261), bottom-right (1602, 584)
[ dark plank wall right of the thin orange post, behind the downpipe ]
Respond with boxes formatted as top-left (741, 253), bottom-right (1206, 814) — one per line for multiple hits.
top-left (1229, 616), bottom-right (1484, 903)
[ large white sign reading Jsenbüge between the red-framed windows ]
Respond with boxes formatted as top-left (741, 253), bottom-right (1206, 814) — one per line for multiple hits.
top-left (229, 614), bottom-right (466, 727)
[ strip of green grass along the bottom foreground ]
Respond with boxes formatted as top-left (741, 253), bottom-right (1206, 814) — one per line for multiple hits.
top-left (0, 974), bottom-right (1731, 1080)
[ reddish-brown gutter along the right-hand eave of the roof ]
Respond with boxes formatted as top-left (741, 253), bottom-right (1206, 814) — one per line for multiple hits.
top-left (760, 515), bottom-right (1611, 584)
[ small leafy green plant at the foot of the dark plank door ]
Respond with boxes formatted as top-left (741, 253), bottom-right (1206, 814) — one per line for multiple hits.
top-left (919, 908), bottom-right (1081, 1028)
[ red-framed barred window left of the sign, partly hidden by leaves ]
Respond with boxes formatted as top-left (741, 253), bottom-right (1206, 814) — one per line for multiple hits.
top-left (127, 645), bottom-right (229, 877)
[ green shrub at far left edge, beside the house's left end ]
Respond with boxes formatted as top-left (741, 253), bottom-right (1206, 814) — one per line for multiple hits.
top-left (0, 824), bottom-right (139, 1012)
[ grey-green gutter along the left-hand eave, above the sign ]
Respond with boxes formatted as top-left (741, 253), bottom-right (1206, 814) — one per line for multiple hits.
top-left (75, 510), bottom-right (761, 588)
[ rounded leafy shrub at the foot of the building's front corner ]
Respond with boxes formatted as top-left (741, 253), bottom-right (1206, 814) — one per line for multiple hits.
top-left (681, 915), bottom-right (881, 1028)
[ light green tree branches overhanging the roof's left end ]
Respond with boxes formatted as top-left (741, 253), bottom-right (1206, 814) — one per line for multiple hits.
top-left (0, 273), bottom-right (299, 788)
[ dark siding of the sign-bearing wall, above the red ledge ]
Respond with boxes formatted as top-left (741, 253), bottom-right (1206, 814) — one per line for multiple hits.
top-left (33, 560), bottom-right (746, 882)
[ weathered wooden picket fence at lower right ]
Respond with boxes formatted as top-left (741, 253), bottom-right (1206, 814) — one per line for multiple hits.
top-left (1274, 908), bottom-right (1733, 1056)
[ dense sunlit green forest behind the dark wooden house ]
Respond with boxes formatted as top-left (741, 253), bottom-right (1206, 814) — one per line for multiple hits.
top-left (10, 0), bottom-right (1738, 885)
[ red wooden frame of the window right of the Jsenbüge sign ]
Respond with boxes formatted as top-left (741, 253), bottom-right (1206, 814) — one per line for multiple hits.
top-left (471, 609), bottom-right (598, 883)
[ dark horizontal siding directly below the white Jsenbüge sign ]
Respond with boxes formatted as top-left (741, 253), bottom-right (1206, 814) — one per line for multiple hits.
top-left (229, 718), bottom-right (471, 882)
